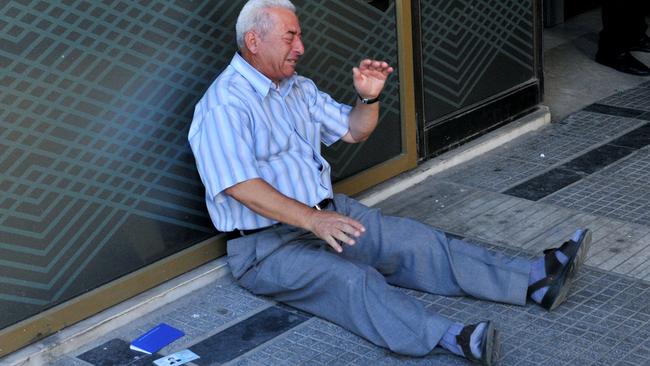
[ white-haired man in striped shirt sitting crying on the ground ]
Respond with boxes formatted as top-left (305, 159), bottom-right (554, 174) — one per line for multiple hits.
top-left (189, 0), bottom-right (590, 365)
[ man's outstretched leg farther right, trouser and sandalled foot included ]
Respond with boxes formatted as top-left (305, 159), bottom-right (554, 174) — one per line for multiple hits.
top-left (336, 196), bottom-right (591, 310)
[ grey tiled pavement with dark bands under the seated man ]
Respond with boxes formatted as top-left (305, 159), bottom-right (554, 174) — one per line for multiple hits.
top-left (8, 82), bottom-right (650, 366)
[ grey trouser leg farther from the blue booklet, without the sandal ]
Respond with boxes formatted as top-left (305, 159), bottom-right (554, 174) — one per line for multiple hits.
top-left (336, 196), bottom-right (530, 305)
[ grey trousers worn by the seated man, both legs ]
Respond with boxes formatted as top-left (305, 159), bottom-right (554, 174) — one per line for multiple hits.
top-left (228, 195), bottom-right (530, 356)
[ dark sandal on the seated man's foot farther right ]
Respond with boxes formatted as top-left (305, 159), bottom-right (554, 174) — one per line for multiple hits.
top-left (528, 229), bottom-right (591, 310)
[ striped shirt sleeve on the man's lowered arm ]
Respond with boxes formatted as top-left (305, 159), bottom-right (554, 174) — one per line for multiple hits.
top-left (189, 105), bottom-right (260, 200)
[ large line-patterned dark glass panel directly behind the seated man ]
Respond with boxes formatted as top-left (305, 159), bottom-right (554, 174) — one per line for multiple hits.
top-left (0, 0), bottom-right (401, 328)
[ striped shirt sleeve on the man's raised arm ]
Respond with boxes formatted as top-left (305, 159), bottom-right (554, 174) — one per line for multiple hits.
top-left (304, 78), bottom-right (352, 146)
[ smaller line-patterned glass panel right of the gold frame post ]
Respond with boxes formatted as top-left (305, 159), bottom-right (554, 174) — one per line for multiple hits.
top-left (420, 0), bottom-right (536, 123)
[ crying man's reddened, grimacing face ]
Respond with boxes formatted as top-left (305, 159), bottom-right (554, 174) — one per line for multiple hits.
top-left (254, 8), bottom-right (305, 83)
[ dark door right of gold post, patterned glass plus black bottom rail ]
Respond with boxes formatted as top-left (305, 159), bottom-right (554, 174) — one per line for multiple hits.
top-left (414, 0), bottom-right (542, 158)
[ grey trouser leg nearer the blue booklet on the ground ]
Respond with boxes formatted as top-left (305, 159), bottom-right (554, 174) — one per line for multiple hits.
top-left (233, 240), bottom-right (453, 356)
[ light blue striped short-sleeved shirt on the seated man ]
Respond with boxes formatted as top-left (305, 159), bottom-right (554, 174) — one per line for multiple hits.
top-left (188, 54), bottom-right (351, 231)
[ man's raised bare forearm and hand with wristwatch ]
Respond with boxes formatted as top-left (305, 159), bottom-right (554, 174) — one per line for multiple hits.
top-left (342, 60), bottom-right (393, 143)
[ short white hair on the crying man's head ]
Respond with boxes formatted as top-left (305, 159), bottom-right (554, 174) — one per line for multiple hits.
top-left (235, 0), bottom-right (296, 49)
